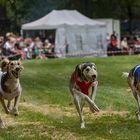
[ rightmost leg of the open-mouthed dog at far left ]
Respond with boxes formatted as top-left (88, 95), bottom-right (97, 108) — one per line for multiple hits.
top-left (12, 93), bottom-right (21, 116)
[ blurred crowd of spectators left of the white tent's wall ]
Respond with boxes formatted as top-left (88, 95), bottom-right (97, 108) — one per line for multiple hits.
top-left (0, 33), bottom-right (54, 60)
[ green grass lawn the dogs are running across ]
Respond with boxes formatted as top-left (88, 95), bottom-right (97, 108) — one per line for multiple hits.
top-left (0, 56), bottom-right (140, 140)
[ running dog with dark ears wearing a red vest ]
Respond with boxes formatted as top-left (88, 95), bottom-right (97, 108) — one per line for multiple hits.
top-left (69, 62), bottom-right (99, 128)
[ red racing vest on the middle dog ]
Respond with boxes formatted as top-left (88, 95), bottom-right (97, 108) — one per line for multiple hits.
top-left (72, 72), bottom-right (92, 95)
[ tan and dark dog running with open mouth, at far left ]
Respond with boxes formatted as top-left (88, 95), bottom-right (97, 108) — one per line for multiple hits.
top-left (0, 61), bottom-right (23, 128)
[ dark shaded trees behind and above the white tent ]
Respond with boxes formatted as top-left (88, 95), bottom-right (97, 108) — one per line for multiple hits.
top-left (0, 0), bottom-right (140, 35)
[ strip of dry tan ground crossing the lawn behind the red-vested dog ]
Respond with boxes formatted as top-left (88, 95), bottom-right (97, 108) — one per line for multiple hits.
top-left (21, 103), bottom-right (130, 117)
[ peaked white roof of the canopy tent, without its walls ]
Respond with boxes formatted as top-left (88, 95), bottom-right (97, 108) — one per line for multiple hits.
top-left (22, 10), bottom-right (105, 30)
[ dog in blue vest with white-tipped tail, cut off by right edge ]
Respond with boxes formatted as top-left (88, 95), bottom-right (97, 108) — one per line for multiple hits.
top-left (123, 65), bottom-right (140, 121)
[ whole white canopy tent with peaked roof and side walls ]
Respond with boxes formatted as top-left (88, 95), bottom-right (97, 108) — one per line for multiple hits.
top-left (22, 10), bottom-right (107, 57)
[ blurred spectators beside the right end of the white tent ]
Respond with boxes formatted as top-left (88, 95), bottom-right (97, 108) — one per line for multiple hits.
top-left (107, 32), bottom-right (140, 56)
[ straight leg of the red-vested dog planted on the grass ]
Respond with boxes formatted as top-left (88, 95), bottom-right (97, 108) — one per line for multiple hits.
top-left (74, 94), bottom-right (85, 128)
